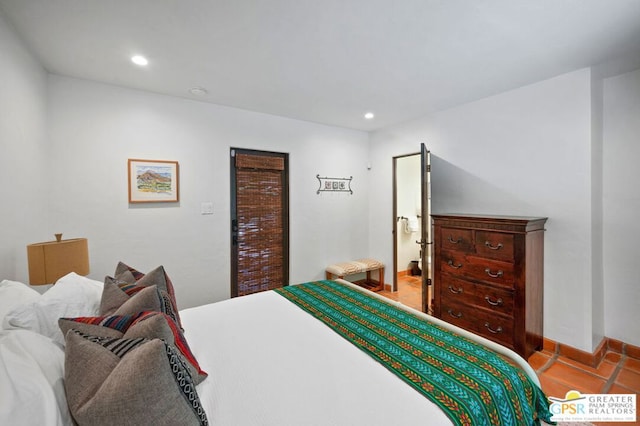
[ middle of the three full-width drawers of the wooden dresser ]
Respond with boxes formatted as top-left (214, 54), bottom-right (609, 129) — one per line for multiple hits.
top-left (440, 275), bottom-right (513, 315)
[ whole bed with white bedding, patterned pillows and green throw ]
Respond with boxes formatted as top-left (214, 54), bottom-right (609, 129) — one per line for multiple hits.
top-left (0, 264), bottom-right (550, 425)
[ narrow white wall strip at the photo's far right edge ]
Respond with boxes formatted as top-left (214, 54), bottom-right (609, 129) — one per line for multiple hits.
top-left (603, 70), bottom-right (640, 346)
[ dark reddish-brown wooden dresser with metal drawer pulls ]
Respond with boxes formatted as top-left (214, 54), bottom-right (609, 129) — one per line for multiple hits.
top-left (432, 214), bottom-right (547, 359)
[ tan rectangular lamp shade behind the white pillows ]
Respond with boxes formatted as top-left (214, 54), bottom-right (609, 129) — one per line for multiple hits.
top-left (27, 238), bottom-right (89, 285)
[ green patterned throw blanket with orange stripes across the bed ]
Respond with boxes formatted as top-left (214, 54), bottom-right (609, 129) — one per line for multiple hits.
top-left (275, 281), bottom-right (551, 426)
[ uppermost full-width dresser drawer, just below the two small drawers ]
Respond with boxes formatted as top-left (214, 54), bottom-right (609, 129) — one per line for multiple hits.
top-left (438, 251), bottom-right (514, 289)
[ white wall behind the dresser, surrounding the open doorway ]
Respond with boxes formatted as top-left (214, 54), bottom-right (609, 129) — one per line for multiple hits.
top-left (369, 70), bottom-right (592, 351)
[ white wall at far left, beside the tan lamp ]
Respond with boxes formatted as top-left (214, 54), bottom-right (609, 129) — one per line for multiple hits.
top-left (0, 14), bottom-right (48, 282)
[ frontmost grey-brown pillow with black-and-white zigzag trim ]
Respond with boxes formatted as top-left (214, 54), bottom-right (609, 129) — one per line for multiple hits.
top-left (65, 330), bottom-right (208, 426)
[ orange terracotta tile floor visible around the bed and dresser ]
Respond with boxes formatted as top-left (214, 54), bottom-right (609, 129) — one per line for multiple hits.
top-left (380, 276), bottom-right (640, 426)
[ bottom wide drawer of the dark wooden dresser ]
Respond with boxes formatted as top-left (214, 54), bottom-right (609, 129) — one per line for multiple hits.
top-left (442, 300), bottom-right (514, 349)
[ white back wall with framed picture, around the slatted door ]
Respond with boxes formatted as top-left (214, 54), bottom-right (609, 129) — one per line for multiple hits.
top-left (43, 76), bottom-right (368, 308)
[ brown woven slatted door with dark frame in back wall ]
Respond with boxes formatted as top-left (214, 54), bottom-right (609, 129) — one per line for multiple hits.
top-left (231, 148), bottom-right (289, 297)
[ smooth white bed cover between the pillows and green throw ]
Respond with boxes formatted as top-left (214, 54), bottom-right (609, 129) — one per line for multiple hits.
top-left (180, 286), bottom-right (451, 426)
